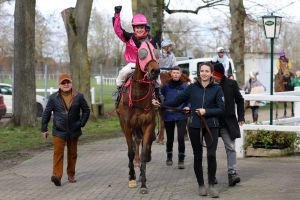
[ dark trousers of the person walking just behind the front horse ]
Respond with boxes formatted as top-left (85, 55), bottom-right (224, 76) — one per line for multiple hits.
top-left (165, 119), bottom-right (187, 154)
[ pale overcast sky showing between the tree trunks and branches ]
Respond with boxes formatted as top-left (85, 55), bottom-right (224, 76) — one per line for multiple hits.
top-left (2, 0), bottom-right (300, 60)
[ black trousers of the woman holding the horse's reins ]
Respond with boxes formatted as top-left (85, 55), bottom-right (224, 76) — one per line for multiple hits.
top-left (189, 128), bottom-right (219, 186)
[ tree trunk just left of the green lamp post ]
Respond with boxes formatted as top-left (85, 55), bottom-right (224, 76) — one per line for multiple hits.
top-left (229, 0), bottom-right (246, 85)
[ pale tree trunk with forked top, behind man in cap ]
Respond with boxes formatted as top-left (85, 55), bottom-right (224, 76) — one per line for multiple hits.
top-left (61, 0), bottom-right (93, 111)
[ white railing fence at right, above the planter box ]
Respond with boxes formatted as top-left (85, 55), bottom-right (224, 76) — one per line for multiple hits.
top-left (235, 87), bottom-right (300, 158)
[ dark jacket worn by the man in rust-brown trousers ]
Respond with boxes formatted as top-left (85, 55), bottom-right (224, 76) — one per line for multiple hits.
top-left (41, 90), bottom-right (90, 140)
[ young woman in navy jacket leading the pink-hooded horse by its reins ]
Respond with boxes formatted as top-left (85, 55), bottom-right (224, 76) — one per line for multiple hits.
top-left (152, 63), bottom-right (224, 198)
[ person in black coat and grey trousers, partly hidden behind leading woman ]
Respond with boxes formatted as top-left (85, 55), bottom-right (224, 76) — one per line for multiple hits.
top-left (213, 63), bottom-right (245, 186)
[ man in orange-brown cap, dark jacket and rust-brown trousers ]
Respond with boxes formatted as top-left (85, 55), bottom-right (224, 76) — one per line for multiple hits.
top-left (41, 73), bottom-right (90, 186)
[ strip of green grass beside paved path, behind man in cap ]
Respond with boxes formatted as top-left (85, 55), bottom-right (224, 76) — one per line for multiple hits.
top-left (0, 117), bottom-right (122, 160)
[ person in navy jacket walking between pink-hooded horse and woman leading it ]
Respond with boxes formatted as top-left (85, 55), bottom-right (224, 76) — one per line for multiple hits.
top-left (161, 68), bottom-right (188, 169)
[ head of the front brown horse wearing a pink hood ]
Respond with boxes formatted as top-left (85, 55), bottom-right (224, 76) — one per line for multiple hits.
top-left (137, 41), bottom-right (160, 80)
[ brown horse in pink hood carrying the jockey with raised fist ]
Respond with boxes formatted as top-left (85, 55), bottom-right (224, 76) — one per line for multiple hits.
top-left (116, 42), bottom-right (160, 194)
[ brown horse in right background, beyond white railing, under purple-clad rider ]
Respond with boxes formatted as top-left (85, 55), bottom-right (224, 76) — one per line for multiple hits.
top-left (275, 59), bottom-right (294, 119)
